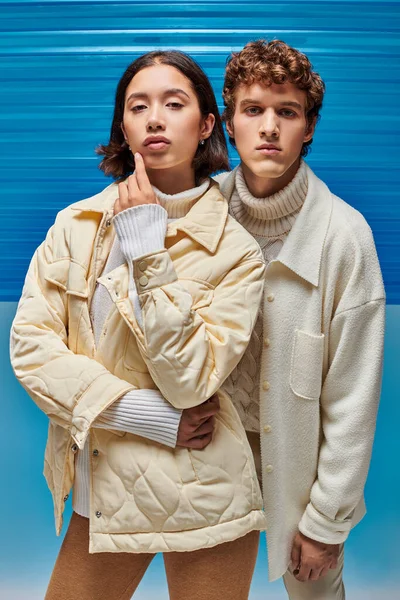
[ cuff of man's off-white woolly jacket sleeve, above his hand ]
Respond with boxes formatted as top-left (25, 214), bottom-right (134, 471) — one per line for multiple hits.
top-left (299, 503), bottom-right (352, 544)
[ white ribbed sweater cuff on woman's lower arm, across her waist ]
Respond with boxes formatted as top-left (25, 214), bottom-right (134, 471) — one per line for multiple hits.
top-left (93, 390), bottom-right (182, 448)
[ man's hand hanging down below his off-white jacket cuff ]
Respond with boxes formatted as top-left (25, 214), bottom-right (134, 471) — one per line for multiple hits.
top-left (291, 532), bottom-right (340, 581)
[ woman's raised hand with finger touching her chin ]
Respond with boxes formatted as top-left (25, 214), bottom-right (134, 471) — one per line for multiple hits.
top-left (114, 152), bottom-right (159, 216)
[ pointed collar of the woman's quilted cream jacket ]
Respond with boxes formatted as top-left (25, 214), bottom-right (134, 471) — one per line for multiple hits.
top-left (70, 180), bottom-right (228, 253)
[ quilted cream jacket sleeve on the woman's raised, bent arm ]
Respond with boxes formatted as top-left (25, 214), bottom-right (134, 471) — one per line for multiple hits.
top-left (125, 246), bottom-right (265, 409)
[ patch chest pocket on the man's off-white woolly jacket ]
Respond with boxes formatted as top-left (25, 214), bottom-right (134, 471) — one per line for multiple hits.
top-left (290, 329), bottom-right (325, 400)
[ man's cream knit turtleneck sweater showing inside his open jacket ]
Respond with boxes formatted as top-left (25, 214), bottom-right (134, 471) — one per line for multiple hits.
top-left (224, 161), bottom-right (308, 433)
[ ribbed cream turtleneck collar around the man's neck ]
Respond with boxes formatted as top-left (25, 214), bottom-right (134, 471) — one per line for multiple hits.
top-left (230, 160), bottom-right (308, 237)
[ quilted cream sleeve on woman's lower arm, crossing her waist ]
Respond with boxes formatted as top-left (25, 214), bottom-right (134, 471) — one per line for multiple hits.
top-left (10, 226), bottom-right (135, 448)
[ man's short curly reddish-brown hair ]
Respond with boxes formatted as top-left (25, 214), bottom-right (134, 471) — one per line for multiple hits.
top-left (222, 40), bottom-right (325, 156)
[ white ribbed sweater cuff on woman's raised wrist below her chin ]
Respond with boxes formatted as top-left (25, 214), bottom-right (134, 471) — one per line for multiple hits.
top-left (113, 204), bottom-right (168, 261)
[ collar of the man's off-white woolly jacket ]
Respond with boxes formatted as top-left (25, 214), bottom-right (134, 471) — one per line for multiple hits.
top-left (220, 165), bottom-right (333, 287)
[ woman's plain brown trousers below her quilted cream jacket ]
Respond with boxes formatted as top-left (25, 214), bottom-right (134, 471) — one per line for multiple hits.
top-left (45, 513), bottom-right (259, 600)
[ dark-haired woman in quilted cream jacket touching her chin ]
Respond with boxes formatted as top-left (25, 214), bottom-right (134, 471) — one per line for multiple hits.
top-left (11, 51), bottom-right (265, 600)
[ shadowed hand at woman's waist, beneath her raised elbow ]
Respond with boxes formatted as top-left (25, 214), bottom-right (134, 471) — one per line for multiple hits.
top-left (176, 394), bottom-right (219, 450)
